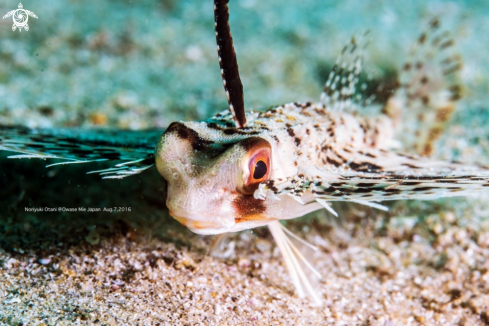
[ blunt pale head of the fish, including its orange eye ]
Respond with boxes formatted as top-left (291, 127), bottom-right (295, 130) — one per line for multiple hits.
top-left (155, 122), bottom-right (286, 234)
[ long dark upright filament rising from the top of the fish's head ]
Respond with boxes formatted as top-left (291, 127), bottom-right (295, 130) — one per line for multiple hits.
top-left (214, 0), bottom-right (246, 128)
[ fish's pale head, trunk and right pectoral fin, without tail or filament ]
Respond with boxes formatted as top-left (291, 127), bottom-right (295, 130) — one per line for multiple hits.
top-left (155, 98), bottom-right (488, 234)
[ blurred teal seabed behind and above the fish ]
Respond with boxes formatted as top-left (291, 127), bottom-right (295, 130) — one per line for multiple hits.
top-left (0, 0), bottom-right (489, 135)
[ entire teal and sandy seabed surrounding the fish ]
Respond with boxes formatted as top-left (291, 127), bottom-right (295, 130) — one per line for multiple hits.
top-left (0, 0), bottom-right (489, 325)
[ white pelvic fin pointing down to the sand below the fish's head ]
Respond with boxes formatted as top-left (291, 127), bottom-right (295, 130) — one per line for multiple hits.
top-left (268, 221), bottom-right (322, 306)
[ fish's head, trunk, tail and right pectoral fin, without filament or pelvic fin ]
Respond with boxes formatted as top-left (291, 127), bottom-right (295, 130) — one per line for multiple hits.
top-left (155, 19), bottom-right (476, 239)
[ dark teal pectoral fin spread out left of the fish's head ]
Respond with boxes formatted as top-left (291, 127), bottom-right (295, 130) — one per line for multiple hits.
top-left (0, 126), bottom-right (162, 179)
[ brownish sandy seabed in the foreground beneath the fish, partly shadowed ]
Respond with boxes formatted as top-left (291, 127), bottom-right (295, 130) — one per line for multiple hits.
top-left (0, 161), bottom-right (489, 325)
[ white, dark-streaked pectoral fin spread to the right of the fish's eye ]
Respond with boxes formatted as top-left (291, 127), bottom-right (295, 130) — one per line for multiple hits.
top-left (260, 151), bottom-right (489, 209)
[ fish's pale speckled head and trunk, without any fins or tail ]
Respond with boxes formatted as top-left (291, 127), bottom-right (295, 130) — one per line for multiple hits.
top-left (155, 103), bottom-right (389, 234)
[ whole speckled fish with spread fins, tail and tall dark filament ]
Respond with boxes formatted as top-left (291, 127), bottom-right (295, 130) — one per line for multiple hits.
top-left (0, 0), bottom-right (489, 305)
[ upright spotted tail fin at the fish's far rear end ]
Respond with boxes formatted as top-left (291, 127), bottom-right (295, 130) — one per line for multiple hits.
top-left (383, 18), bottom-right (462, 156)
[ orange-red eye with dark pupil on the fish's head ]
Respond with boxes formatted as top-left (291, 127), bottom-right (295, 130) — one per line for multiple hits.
top-left (238, 137), bottom-right (272, 195)
